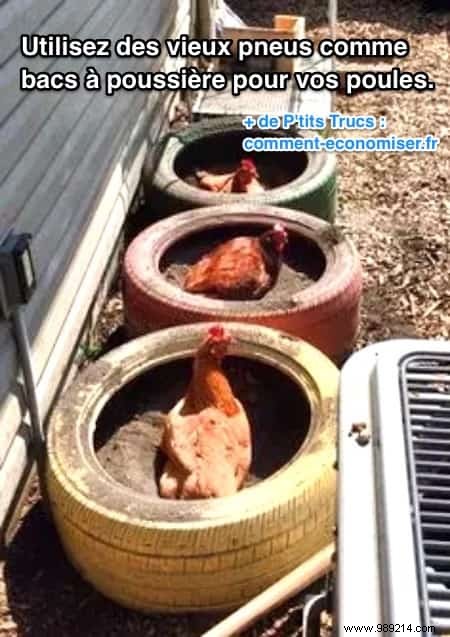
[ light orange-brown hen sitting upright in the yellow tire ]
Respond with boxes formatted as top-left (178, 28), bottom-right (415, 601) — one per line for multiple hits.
top-left (160, 326), bottom-right (252, 499)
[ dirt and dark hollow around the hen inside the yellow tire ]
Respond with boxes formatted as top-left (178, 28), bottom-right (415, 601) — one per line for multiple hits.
top-left (94, 357), bottom-right (311, 497)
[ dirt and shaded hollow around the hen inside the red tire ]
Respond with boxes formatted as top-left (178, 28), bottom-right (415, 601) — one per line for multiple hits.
top-left (159, 225), bottom-right (326, 311)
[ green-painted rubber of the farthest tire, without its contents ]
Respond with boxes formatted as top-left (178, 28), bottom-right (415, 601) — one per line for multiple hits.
top-left (144, 117), bottom-right (337, 221)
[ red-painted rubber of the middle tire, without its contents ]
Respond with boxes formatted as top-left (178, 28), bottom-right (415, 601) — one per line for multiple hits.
top-left (123, 204), bottom-right (362, 362)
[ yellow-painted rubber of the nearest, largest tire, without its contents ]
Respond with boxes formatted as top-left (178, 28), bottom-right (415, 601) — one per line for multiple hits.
top-left (47, 323), bottom-right (338, 612)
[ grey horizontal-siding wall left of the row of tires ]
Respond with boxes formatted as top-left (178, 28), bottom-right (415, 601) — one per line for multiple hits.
top-left (0, 0), bottom-right (190, 526)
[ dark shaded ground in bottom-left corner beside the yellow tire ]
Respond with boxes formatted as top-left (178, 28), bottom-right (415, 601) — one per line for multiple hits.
top-left (0, 502), bottom-right (222, 637)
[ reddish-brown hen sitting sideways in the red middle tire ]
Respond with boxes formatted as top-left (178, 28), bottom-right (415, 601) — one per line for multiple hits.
top-left (183, 224), bottom-right (288, 300)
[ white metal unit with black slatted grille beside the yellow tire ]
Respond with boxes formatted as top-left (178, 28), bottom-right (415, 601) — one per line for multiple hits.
top-left (334, 340), bottom-right (450, 636)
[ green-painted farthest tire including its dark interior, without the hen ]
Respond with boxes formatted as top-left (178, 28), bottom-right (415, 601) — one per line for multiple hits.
top-left (144, 117), bottom-right (337, 221)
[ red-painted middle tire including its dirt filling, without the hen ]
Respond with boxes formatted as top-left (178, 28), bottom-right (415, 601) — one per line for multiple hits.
top-left (123, 204), bottom-right (362, 362)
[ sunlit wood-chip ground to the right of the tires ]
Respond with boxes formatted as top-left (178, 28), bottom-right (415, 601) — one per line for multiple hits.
top-left (230, 0), bottom-right (450, 346)
